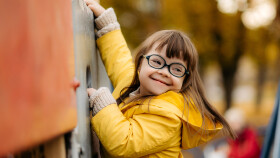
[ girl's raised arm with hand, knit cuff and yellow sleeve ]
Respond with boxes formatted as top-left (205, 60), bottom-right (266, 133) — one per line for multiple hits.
top-left (85, 0), bottom-right (134, 98)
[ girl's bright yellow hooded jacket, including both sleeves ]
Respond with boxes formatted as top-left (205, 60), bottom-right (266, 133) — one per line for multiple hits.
top-left (91, 30), bottom-right (222, 158)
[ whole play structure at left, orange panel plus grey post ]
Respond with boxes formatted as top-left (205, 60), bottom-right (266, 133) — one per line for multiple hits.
top-left (0, 0), bottom-right (110, 157)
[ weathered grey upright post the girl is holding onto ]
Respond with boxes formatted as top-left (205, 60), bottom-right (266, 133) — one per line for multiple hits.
top-left (70, 0), bottom-right (110, 157)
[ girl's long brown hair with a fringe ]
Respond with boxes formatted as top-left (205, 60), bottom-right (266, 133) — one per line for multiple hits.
top-left (117, 30), bottom-right (236, 138)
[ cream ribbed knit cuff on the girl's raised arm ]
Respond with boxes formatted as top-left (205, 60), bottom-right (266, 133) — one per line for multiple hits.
top-left (95, 8), bottom-right (120, 37)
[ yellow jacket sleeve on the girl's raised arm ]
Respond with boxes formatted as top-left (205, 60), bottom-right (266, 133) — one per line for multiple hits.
top-left (97, 29), bottom-right (134, 98)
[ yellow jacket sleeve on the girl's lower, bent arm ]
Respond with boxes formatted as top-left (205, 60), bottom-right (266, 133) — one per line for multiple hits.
top-left (92, 104), bottom-right (181, 157)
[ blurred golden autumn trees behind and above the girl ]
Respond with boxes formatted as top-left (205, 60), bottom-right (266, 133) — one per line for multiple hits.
top-left (101, 0), bottom-right (280, 126)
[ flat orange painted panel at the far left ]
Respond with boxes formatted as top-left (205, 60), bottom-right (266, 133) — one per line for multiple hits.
top-left (0, 0), bottom-right (77, 156)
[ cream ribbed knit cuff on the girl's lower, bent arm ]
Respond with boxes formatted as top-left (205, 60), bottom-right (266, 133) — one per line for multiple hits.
top-left (89, 87), bottom-right (116, 116)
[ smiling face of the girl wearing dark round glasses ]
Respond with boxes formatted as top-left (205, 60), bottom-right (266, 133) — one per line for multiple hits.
top-left (138, 44), bottom-right (187, 95)
